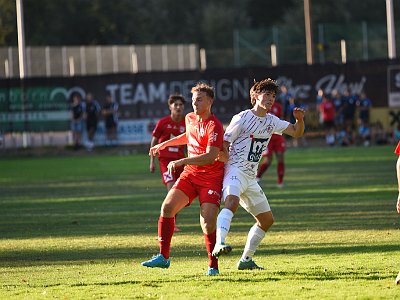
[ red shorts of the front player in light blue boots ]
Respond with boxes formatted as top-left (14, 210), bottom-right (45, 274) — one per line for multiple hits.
top-left (172, 171), bottom-right (223, 207)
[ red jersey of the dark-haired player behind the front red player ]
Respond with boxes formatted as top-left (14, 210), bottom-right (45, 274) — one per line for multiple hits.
top-left (153, 116), bottom-right (185, 159)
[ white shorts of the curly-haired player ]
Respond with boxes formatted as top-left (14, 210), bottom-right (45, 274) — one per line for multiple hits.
top-left (222, 165), bottom-right (271, 217)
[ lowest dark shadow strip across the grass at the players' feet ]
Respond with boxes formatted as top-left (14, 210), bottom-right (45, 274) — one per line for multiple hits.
top-left (0, 244), bottom-right (399, 267)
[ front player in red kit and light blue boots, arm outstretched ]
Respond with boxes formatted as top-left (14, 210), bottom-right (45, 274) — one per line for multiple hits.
top-left (142, 83), bottom-right (224, 275)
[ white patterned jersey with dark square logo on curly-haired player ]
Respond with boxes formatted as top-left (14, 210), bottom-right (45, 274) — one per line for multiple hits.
top-left (224, 109), bottom-right (290, 178)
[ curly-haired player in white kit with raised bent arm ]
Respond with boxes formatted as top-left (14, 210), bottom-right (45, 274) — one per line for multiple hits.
top-left (212, 78), bottom-right (305, 270)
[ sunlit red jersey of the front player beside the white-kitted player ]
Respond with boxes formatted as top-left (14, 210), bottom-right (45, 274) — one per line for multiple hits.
top-left (185, 112), bottom-right (224, 180)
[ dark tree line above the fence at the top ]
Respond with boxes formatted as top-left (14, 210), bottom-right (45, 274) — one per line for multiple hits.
top-left (0, 0), bottom-right (392, 49)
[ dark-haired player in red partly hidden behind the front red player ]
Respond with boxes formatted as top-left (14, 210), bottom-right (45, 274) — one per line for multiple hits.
top-left (150, 95), bottom-right (186, 232)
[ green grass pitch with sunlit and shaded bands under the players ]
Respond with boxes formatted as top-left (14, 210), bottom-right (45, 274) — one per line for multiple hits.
top-left (0, 146), bottom-right (400, 299)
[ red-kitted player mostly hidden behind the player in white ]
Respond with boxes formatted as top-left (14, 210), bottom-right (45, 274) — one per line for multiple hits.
top-left (257, 102), bottom-right (286, 187)
